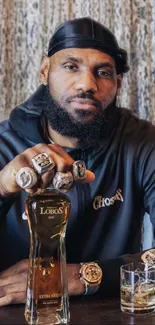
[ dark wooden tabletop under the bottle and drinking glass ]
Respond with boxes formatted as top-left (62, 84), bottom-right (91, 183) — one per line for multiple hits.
top-left (0, 297), bottom-right (155, 325)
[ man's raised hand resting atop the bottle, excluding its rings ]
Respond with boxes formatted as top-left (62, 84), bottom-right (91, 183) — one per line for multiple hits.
top-left (0, 144), bottom-right (95, 197)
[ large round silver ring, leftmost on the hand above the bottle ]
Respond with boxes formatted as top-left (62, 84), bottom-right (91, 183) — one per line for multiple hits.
top-left (16, 167), bottom-right (38, 190)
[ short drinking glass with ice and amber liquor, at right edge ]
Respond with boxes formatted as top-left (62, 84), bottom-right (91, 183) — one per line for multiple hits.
top-left (120, 263), bottom-right (155, 315)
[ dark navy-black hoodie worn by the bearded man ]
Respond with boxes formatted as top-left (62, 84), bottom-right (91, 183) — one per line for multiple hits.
top-left (0, 86), bottom-right (155, 296)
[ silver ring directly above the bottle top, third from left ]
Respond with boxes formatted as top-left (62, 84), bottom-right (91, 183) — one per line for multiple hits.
top-left (52, 172), bottom-right (73, 190)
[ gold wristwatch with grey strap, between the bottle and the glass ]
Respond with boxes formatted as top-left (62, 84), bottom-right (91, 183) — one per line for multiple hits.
top-left (79, 262), bottom-right (103, 295)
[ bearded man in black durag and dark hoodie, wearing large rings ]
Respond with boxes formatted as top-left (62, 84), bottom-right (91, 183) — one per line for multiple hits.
top-left (0, 18), bottom-right (155, 306)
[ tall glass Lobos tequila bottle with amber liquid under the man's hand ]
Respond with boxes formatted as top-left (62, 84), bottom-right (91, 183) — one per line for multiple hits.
top-left (25, 189), bottom-right (70, 325)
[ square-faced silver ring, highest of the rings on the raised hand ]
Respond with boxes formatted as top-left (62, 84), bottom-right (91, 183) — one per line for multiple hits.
top-left (32, 152), bottom-right (55, 174)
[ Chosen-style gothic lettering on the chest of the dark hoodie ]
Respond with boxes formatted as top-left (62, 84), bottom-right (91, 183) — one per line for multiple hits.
top-left (93, 188), bottom-right (123, 210)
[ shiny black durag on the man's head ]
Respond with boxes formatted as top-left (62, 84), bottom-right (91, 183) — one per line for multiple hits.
top-left (48, 17), bottom-right (129, 74)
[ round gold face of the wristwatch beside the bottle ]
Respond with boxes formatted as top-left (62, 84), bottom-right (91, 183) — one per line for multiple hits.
top-left (82, 263), bottom-right (102, 283)
